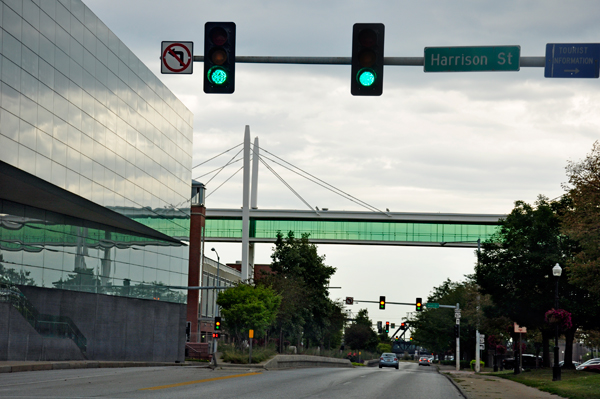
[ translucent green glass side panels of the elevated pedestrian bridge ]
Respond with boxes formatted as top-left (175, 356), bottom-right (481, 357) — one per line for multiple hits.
top-left (205, 219), bottom-right (498, 243)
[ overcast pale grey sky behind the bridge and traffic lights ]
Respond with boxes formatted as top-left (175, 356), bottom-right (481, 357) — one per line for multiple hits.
top-left (84, 0), bottom-right (600, 332)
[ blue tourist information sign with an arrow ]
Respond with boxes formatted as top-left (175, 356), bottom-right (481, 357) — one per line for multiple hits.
top-left (544, 43), bottom-right (600, 78)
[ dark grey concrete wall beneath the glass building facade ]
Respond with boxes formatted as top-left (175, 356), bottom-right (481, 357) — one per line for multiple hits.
top-left (0, 286), bottom-right (186, 362)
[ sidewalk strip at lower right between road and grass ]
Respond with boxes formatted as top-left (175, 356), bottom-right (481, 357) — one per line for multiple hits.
top-left (437, 365), bottom-right (561, 399)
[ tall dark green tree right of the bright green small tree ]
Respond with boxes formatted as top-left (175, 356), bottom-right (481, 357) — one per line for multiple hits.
top-left (271, 231), bottom-right (343, 345)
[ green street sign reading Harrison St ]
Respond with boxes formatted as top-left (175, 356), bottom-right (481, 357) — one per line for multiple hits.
top-left (423, 46), bottom-right (521, 72)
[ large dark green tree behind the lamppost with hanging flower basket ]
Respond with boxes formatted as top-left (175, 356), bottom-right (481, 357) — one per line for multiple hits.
top-left (475, 196), bottom-right (595, 366)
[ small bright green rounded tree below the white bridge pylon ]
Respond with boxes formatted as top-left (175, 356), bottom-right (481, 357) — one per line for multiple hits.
top-left (217, 283), bottom-right (281, 347)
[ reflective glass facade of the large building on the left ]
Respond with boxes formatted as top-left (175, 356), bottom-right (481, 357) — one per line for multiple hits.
top-left (0, 0), bottom-right (193, 303)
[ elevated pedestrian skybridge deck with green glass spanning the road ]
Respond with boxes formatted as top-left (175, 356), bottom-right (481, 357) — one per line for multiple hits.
top-left (204, 209), bottom-right (506, 247)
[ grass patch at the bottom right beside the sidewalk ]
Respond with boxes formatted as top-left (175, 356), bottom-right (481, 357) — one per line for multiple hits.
top-left (491, 368), bottom-right (600, 399)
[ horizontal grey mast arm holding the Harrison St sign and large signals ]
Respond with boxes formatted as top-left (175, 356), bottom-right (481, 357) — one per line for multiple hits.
top-left (194, 55), bottom-right (546, 67)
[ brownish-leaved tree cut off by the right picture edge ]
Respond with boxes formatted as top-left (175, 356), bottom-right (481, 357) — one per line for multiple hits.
top-left (562, 141), bottom-right (600, 296)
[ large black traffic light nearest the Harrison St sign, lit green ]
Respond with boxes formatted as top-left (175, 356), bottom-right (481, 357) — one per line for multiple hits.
top-left (350, 24), bottom-right (385, 96)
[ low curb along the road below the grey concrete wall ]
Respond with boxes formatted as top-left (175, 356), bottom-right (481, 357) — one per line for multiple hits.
top-left (0, 361), bottom-right (196, 373)
